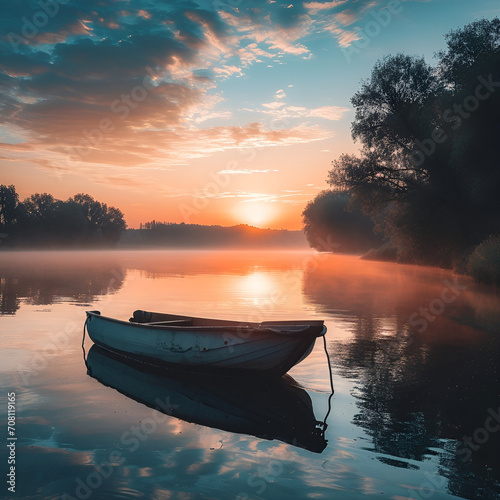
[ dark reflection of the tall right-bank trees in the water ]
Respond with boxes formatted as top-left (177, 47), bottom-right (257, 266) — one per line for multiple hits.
top-left (304, 256), bottom-right (500, 498)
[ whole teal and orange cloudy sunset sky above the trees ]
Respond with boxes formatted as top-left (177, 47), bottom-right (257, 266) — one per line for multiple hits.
top-left (0, 0), bottom-right (500, 229)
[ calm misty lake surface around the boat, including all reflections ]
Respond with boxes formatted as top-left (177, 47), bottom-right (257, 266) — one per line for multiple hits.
top-left (0, 251), bottom-right (500, 500)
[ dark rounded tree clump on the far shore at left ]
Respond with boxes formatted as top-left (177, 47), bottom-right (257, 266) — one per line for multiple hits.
top-left (0, 185), bottom-right (127, 247)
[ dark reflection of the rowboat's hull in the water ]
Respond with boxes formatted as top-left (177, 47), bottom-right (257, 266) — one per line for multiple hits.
top-left (86, 345), bottom-right (327, 453)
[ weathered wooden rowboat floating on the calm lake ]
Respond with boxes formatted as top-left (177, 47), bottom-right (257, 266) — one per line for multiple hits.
top-left (86, 311), bottom-right (326, 377)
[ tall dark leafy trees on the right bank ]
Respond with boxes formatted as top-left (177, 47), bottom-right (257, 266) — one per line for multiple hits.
top-left (303, 18), bottom-right (500, 282)
